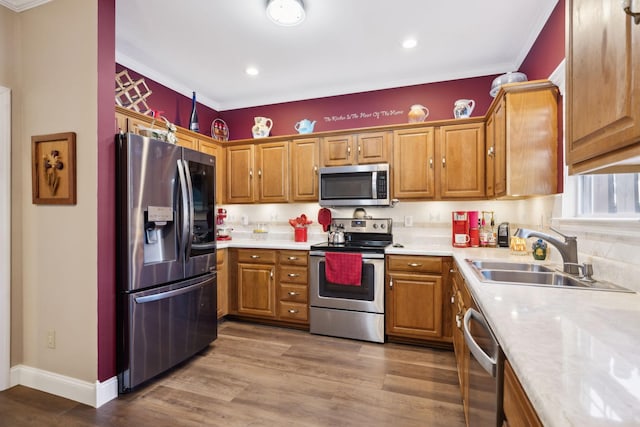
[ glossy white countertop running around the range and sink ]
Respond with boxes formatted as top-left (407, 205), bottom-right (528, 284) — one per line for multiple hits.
top-left (218, 239), bottom-right (640, 427)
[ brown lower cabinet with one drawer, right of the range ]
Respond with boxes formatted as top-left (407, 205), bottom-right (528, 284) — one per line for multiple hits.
top-left (385, 255), bottom-right (451, 344)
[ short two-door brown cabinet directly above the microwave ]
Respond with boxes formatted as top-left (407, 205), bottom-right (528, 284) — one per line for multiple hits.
top-left (322, 131), bottom-right (391, 166)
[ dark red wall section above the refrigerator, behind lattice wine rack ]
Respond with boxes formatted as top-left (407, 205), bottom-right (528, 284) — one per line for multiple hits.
top-left (114, 64), bottom-right (219, 136)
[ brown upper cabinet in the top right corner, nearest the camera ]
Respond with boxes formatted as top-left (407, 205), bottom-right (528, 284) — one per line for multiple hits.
top-left (566, 0), bottom-right (640, 174)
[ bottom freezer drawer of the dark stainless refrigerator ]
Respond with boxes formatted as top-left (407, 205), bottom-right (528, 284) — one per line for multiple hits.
top-left (118, 273), bottom-right (217, 393)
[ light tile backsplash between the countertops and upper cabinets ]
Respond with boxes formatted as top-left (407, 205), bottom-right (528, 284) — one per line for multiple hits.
top-left (224, 195), bottom-right (640, 292)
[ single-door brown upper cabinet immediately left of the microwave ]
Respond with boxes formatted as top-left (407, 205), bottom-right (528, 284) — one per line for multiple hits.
top-left (290, 138), bottom-right (320, 202)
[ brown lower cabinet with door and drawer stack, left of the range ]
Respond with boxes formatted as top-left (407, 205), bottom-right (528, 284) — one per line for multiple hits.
top-left (229, 248), bottom-right (309, 328)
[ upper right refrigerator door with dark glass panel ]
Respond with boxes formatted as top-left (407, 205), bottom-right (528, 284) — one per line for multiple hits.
top-left (183, 148), bottom-right (216, 277)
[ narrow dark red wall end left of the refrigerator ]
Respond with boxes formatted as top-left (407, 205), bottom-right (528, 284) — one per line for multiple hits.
top-left (96, 0), bottom-right (116, 382)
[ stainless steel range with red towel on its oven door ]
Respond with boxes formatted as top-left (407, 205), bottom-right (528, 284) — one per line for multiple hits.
top-left (309, 218), bottom-right (393, 343)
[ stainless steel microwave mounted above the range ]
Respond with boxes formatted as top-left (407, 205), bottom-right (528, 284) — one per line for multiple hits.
top-left (319, 163), bottom-right (391, 206)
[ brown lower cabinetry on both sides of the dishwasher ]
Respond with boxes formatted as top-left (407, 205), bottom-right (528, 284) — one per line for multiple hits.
top-left (450, 264), bottom-right (542, 427)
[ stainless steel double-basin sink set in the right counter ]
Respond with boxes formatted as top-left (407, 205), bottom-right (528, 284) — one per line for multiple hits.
top-left (467, 260), bottom-right (633, 292)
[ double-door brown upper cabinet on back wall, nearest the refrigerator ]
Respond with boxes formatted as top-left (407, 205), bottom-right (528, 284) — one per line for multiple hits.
top-left (226, 141), bottom-right (289, 203)
